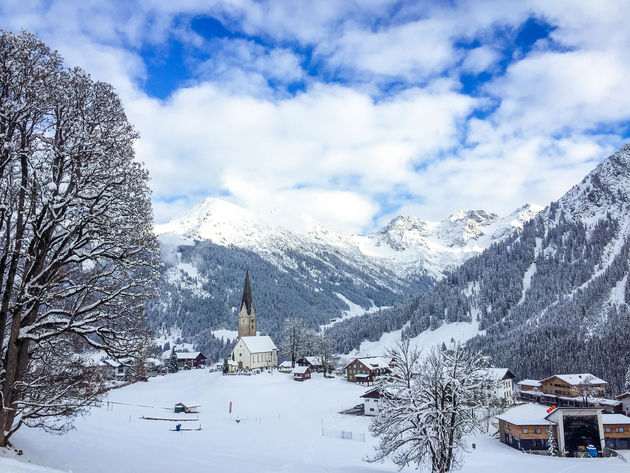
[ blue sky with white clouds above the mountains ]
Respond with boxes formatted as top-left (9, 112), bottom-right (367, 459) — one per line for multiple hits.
top-left (0, 0), bottom-right (630, 234)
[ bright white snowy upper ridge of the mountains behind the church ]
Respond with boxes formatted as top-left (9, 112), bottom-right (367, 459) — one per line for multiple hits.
top-left (155, 198), bottom-right (542, 284)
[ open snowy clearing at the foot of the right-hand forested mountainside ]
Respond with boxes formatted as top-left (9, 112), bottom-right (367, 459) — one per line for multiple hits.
top-left (349, 321), bottom-right (484, 357)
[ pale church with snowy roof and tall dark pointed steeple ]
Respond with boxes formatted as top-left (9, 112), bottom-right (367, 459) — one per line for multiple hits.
top-left (230, 270), bottom-right (278, 370)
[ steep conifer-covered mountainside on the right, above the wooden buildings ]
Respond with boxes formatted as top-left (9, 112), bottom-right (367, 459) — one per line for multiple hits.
top-left (331, 146), bottom-right (630, 391)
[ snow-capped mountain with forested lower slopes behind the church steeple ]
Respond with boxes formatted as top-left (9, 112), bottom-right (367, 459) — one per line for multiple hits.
top-left (149, 199), bottom-right (540, 358)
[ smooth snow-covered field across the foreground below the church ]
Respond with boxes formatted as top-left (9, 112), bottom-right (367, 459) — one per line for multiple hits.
top-left (0, 370), bottom-right (630, 473)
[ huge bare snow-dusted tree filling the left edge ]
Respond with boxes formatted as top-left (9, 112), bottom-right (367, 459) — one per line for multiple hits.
top-left (0, 31), bottom-right (157, 446)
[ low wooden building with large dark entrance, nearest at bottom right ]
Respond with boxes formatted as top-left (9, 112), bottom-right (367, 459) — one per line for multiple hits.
top-left (496, 403), bottom-right (630, 456)
